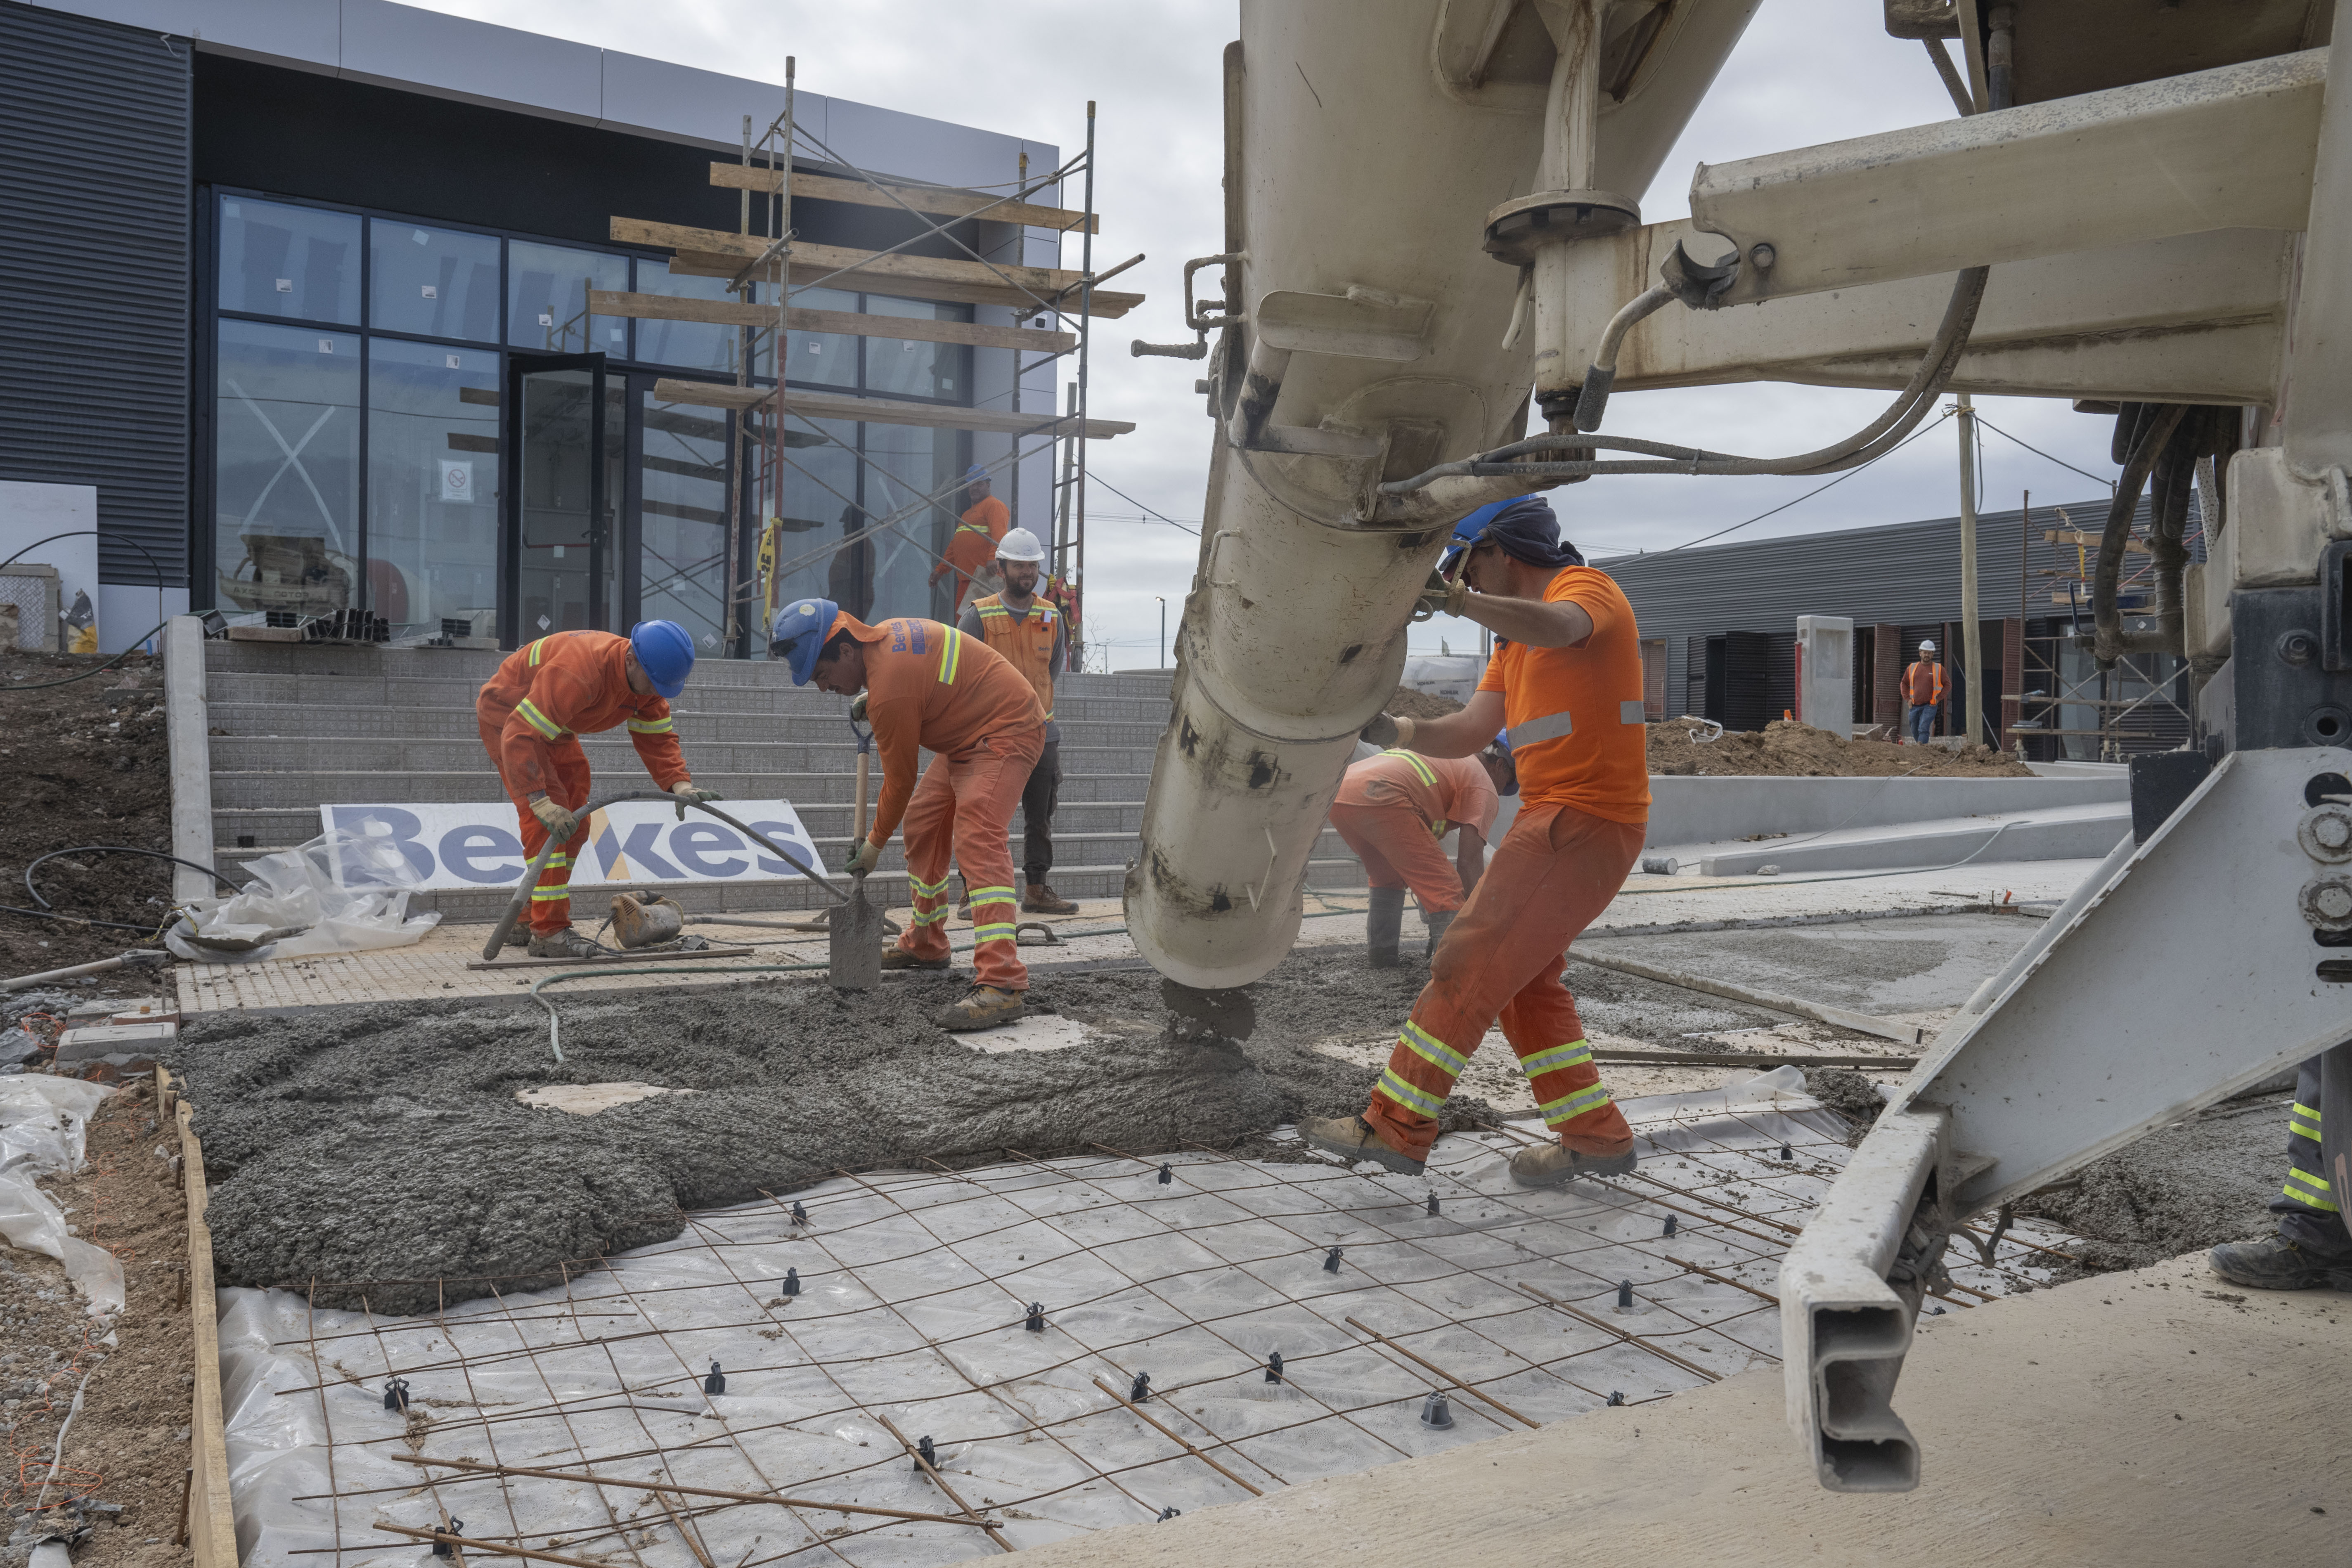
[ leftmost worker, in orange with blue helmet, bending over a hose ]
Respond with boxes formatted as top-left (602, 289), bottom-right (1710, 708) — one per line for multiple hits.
top-left (473, 621), bottom-right (720, 959)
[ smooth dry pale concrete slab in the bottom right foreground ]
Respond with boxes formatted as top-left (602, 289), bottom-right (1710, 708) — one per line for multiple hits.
top-left (1023, 1258), bottom-right (2352, 1568)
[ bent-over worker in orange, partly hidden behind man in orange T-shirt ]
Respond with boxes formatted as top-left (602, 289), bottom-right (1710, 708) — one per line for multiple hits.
top-left (1331, 736), bottom-right (1519, 969)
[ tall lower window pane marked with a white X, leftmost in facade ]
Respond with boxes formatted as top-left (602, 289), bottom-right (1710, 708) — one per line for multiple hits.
top-left (214, 320), bottom-right (360, 616)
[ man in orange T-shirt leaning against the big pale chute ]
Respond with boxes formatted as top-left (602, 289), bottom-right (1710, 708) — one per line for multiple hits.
top-left (1298, 496), bottom-right (1649, 1187)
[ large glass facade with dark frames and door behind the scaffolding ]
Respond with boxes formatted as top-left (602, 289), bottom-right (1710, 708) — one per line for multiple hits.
top-left (198, 190), bottom-right (971, 653)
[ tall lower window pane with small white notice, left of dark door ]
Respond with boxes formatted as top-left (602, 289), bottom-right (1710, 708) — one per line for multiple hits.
top-left (367, 338), bottom-right (499, 637)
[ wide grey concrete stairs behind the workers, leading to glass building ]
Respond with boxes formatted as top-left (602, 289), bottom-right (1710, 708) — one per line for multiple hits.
top-left (202, 642), bottom-right (1362, 922)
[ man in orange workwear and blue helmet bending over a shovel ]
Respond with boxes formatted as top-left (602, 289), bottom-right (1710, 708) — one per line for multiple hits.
top-left (767, 599), bottom-right (1044, 1030)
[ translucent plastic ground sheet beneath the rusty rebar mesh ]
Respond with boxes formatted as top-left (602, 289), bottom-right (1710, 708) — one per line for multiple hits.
top-left (221, 1093), bottom-right (2068, 1568)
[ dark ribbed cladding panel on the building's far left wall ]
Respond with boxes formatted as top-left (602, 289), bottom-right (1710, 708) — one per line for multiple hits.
top-left (0, 0), bottom-right (191, 585)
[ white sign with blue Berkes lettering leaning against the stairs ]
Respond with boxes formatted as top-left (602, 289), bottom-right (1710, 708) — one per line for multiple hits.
top-left (317, 799), bottom-right (823, 891)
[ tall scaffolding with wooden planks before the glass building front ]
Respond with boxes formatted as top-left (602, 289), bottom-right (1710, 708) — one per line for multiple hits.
top-left (588, 59), bottom-right (1143, 660)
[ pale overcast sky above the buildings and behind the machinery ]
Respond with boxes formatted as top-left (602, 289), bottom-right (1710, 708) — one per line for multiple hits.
top-left (412, 0), bottom-right (2115, 668)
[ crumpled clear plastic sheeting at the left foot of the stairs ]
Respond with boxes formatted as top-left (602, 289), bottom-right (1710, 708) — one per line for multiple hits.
top-left (162, 830), bottom-right (440, 964)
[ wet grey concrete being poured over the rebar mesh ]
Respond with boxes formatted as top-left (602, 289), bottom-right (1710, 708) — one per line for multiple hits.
top-left (174, 950), bottom-right (1491, 1312)
